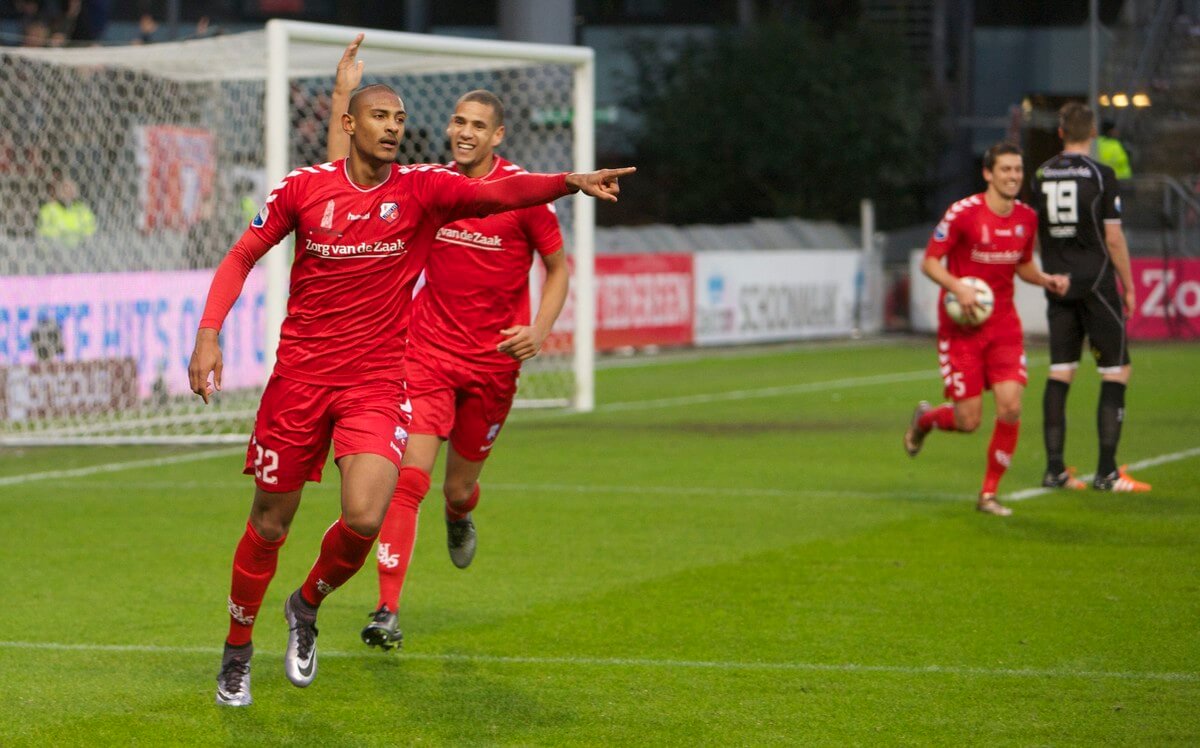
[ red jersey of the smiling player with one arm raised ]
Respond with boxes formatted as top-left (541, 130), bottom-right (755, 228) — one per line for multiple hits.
top-left (409, 156), bottom-right (563, 371)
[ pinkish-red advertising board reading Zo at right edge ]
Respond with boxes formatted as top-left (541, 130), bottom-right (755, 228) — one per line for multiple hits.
top-left (1128, 257), bottom-right (1200, 340)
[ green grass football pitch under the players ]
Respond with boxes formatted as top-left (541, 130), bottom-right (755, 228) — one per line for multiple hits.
top-left (0, 339), bottom-right (1200, 746)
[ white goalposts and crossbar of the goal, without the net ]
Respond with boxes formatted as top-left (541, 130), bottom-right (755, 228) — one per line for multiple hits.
top-left (264, 19), bottom-right (596, 412)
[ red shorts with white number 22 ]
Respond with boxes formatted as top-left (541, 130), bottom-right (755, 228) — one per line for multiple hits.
top-left (242, 373), bottom-right (409, 492)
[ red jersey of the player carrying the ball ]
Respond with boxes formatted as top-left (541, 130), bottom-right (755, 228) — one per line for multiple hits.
top-left (925, 192), bottom-right (1038, 334)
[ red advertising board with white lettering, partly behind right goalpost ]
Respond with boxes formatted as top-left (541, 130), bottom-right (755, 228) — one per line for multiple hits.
top-left (547, 253), bottom-right (695, 351)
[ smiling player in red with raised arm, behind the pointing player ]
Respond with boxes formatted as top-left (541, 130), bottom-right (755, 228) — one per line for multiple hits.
top-left (329, 38), bottom-right (569, 650)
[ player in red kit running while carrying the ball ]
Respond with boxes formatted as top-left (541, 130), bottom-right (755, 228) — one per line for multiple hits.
top-left (904, 143), bottom-right (1069, 516)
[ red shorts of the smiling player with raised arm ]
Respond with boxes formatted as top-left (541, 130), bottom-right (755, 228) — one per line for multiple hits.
top-left (404, 348), bottom-right (521, 461)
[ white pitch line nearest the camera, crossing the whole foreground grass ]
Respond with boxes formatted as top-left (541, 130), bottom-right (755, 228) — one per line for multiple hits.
top-left (0, 641), bottom-right (1200, 683)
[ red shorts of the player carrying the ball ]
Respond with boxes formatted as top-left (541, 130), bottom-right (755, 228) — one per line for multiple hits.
top-left (937, 318), bottom-right (1028, 401)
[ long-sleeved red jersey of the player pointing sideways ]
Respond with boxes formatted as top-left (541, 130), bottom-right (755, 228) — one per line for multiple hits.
top-left (200, 160), bottom-right (569, 385)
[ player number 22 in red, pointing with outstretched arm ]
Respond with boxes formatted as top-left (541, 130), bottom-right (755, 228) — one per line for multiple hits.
top-left (188, 71), bottom-right (632, 706)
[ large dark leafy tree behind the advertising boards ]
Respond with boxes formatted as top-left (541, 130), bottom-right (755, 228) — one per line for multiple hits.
top-left (628, 23), bottom-right (940, 228)
